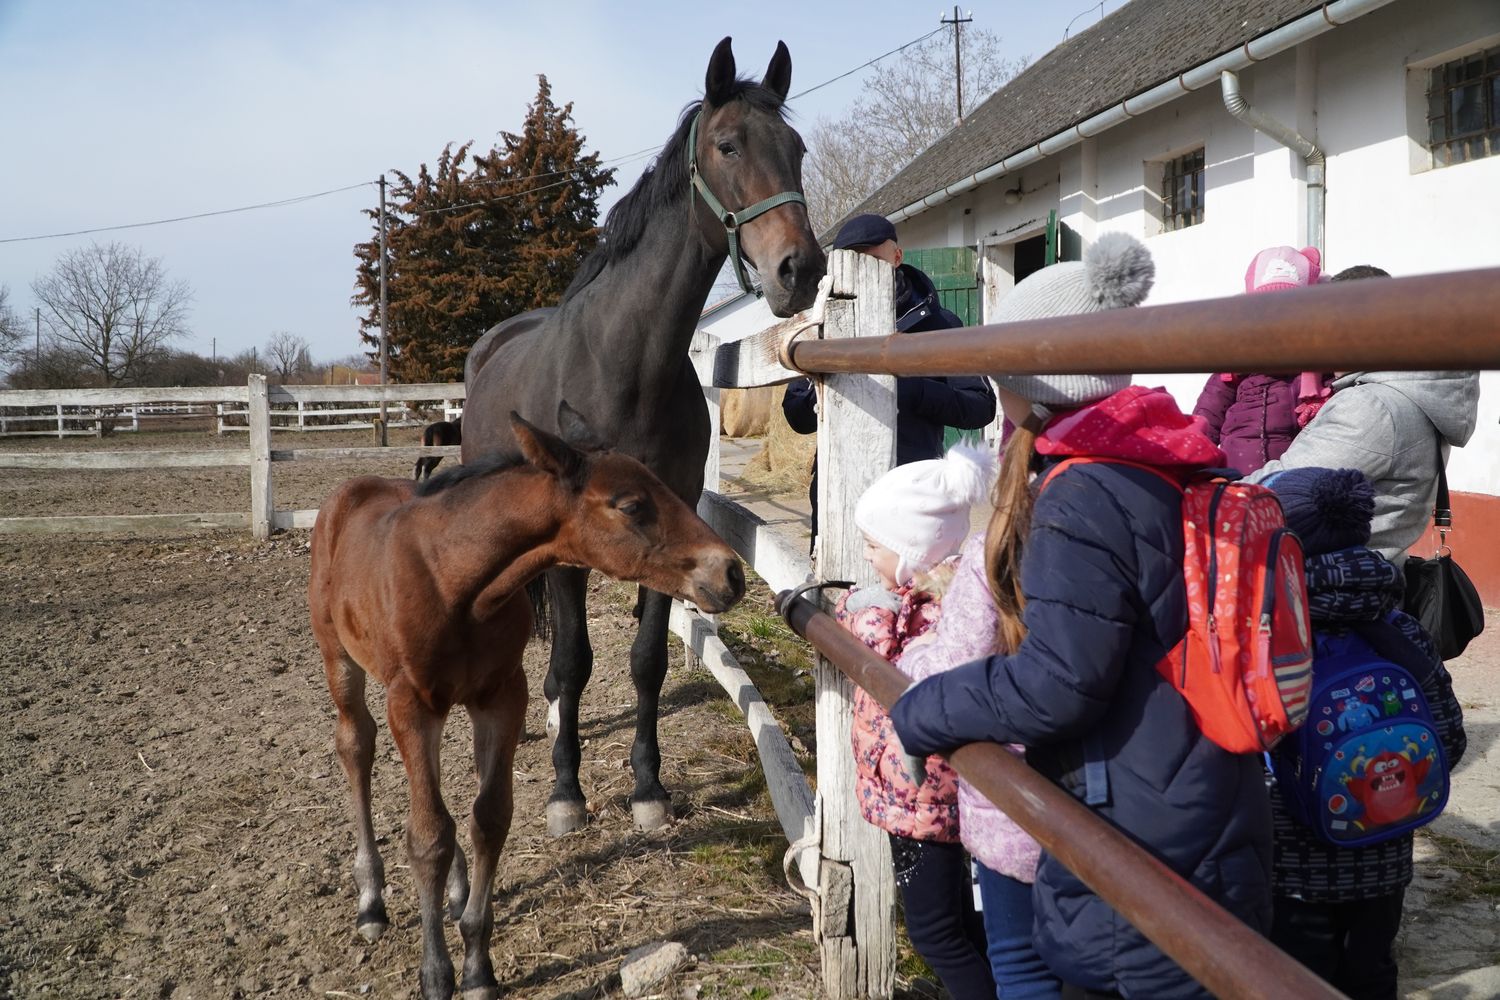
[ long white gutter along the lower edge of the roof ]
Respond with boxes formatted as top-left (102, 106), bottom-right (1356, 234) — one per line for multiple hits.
top-left (887, 0), bottom-right (1395, 223)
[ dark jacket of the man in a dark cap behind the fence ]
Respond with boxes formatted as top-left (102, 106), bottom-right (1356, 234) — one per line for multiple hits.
top-left (782, 264), bottom-right (995, 535)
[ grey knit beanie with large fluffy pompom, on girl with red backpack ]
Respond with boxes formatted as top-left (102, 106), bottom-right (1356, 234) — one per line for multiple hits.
top-left (992, 232), bottom-right (1157, 408)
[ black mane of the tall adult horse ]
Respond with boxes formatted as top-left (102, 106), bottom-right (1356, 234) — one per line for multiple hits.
top-left (563, 78), bottom-right (786, 301)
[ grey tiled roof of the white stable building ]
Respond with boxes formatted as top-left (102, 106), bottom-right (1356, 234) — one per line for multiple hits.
top-left (855, 0), bottom-right (1323, 214)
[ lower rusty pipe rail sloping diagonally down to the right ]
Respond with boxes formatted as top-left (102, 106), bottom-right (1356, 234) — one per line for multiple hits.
top-left (776, 590), bottom-right (1344, 1000)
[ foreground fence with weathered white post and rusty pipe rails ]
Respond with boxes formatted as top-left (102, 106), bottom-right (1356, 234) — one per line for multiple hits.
top-left (699, 252), bottom-right (1500, 1000)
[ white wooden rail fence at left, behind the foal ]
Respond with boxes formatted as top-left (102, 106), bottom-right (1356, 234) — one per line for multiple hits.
top-left (0, 375), bottom-right (465, 538)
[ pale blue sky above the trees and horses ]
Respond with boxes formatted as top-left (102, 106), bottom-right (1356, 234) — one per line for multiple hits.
top-left (0, 0), bottom-right (1121, 361)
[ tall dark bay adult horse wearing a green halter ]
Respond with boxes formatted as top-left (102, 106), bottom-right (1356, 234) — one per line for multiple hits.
top-left (464, 39), bottom-right (827, 835)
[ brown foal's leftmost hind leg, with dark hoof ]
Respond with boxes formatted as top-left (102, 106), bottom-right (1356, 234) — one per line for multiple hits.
top-left (324, 654), bottom-right (390, 942)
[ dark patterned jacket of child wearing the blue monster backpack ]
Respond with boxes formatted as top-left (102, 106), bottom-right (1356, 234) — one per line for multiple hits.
top-left (1271, 547), bottom-right (1469, 903)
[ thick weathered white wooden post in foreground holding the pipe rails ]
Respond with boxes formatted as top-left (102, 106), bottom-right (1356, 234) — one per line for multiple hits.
top-left (813, 250), bottom-right (896, 1000)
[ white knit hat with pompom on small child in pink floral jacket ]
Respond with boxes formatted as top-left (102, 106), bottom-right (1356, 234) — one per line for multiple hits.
top-left (854, 444), bottom-right (996, 583)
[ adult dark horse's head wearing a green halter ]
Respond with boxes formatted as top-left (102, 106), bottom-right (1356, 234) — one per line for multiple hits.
top-left (689, 37), bottom-right (828, 316)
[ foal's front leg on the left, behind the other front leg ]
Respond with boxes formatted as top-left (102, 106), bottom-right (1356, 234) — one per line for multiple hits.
top-left (386, 681), bottom-right (456, 999)
